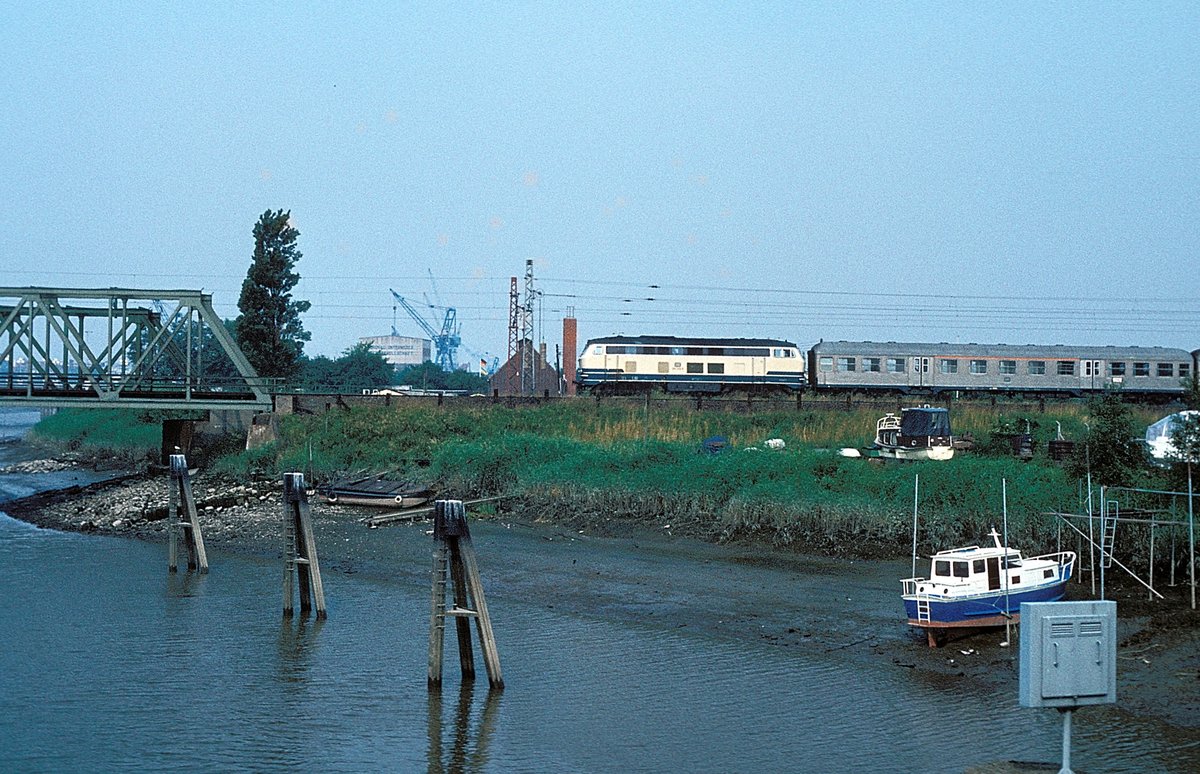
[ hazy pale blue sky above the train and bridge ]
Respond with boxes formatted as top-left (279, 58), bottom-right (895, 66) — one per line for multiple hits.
top-left (0, 0), bottom-right (1200, 361)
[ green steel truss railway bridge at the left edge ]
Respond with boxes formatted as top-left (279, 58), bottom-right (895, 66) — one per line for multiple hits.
top-left (0, 288), bottom-right (271, 409)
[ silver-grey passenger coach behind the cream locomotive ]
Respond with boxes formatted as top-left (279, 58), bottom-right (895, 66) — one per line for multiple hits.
top-left (809, 341), bottom-right (1196, 396)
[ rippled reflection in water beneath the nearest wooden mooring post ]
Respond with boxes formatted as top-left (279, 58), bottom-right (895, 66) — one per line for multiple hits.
top-left (428, 682), bottom-right (500, 774)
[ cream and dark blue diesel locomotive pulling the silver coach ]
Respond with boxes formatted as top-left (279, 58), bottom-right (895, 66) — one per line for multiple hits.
top-left (575, 336), bottom-right (805, 392)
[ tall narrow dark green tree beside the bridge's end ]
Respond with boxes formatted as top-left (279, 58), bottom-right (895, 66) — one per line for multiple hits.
top-left (235, 210), bottom-right (312, 379)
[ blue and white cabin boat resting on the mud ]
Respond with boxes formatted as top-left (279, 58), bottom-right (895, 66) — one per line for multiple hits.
top-left (900, 529), bottom-right (1075, 648)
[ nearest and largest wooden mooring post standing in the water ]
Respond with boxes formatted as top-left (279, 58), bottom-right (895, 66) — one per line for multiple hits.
top-left (430, 500), bottom-right (504, 690)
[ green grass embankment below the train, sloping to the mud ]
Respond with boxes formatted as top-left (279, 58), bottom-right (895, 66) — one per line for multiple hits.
top-left (238, 401), bottom-right (1147, 553)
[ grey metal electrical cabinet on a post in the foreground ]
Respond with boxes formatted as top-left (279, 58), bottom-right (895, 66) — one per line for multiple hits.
top-left (1019, 601), bottom-right (1117, 709)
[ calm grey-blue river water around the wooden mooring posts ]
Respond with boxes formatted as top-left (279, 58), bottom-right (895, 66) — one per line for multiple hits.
top-left (0, 412), bottom-right (1200, 772)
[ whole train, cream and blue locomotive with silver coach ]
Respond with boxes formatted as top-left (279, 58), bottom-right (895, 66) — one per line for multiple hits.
top-left (576, 336), bottom-right (1200, 397)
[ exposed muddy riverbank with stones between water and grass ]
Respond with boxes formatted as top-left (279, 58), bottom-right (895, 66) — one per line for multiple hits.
top-left (7, 453), bottom-right (1200, 744)
